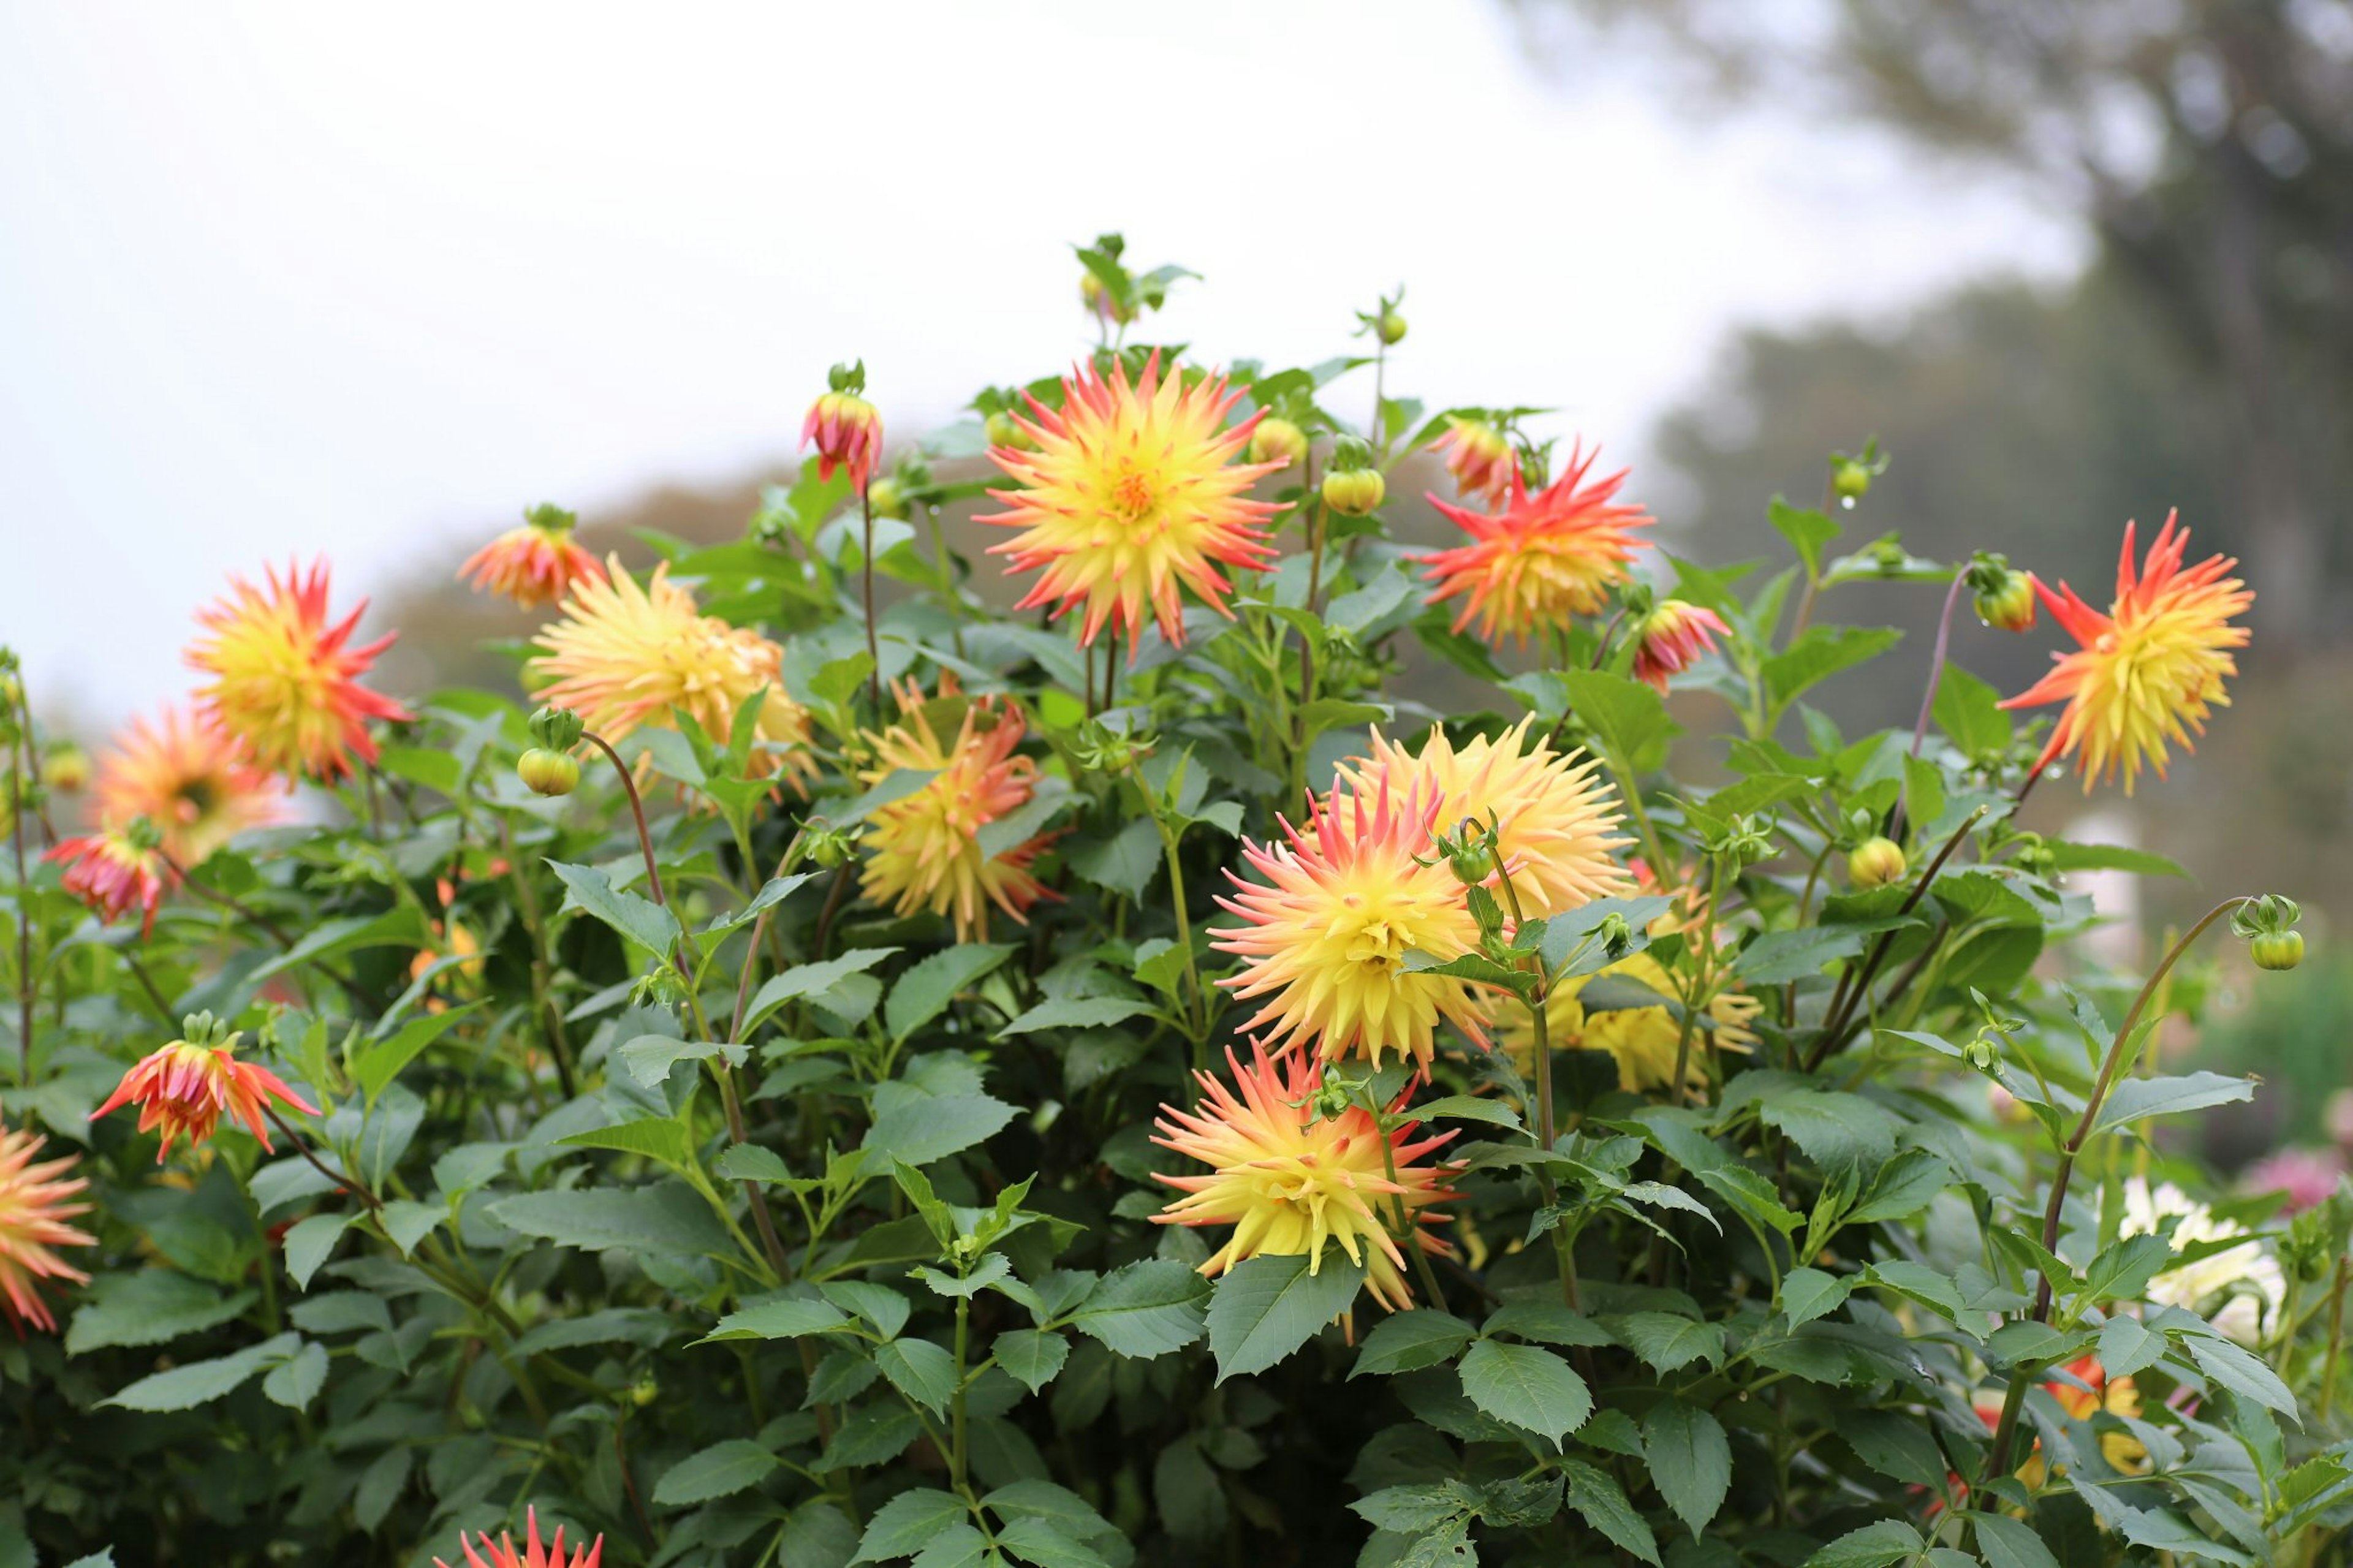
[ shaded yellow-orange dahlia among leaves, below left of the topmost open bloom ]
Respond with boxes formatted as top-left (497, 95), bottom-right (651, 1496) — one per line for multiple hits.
top-left (859, 676), bottom-right (1051, 942)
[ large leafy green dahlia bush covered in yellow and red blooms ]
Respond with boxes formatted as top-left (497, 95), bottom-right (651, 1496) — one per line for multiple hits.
top-left (0, 238), bottom-right (2353, 1568)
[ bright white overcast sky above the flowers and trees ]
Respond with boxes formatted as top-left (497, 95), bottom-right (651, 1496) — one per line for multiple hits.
top-left (0, 0), bottom-right (2078, 727)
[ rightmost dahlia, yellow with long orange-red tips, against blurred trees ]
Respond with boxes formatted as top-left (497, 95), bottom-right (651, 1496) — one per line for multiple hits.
top-left (2003, 513), bottom-right (2254, 796)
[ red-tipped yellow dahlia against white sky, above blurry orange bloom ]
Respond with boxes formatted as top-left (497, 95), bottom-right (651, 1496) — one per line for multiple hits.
top-left (188, 560), bottom-right (409, 789)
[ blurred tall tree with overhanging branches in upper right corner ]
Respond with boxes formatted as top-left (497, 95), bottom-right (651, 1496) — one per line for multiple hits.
top-left (1522, 0), bottom-right (2353, 652)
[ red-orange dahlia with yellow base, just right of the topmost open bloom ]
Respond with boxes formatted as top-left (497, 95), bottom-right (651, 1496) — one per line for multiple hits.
top-left (1421, 447), bottom-right (1652, 645)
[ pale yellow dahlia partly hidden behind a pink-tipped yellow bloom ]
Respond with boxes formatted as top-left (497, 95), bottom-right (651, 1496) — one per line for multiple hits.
top-left (1341, 718), bottom-right (1633, 916)
